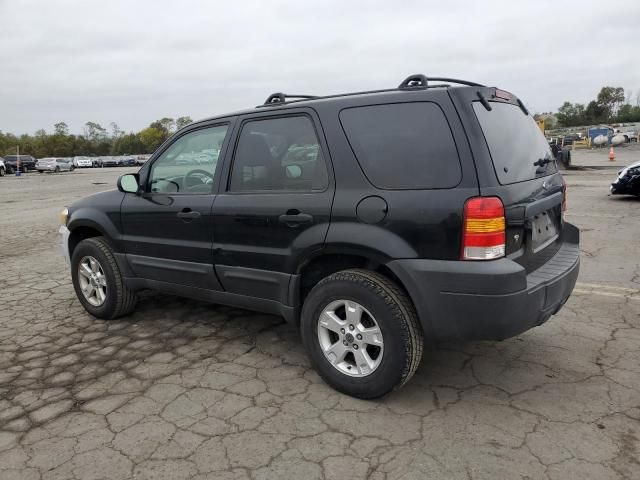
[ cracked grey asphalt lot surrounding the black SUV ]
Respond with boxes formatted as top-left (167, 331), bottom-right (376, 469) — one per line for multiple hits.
top-left (0, 163), bottom-right (640, 480)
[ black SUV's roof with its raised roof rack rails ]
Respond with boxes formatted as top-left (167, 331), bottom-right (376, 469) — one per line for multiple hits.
top-left (191, 74), bottom-right (485, 125)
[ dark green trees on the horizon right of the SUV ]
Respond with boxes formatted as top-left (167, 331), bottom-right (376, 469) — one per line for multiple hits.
top-left (547, 87), bottom-right (640, 128)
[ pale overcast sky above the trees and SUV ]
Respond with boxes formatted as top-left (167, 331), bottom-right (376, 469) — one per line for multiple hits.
top-left (0, 0), bottom-right (640, 133)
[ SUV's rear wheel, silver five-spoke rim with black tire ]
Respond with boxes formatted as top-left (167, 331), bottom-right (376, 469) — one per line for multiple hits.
top-left (301, 269), bottom-right (423, 399)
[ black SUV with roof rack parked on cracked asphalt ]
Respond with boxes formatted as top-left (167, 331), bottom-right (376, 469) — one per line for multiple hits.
top-left (60, 75), bottom-right (579, 398)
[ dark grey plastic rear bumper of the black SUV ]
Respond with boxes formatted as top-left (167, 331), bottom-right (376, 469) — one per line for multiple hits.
top-left (388, 223), bottom-right (580, 340)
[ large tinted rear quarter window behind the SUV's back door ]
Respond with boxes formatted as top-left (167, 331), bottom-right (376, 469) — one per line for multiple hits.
top-left (340, 102), bottom-right (462, 190)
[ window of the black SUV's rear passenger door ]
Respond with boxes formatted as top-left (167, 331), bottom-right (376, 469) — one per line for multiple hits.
top-left (229, 115), bottom-right (328, 192)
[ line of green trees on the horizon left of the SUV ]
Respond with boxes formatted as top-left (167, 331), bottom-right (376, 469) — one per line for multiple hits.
top-left (0, 116), bottom-right (193, 158)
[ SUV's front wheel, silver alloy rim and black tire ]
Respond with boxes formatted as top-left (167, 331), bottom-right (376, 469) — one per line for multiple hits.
top-left (71, 237), bottom-right (136, 319)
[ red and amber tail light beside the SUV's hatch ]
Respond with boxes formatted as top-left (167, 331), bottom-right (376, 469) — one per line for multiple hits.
top-left (462, 197), bottom-right (505, 260)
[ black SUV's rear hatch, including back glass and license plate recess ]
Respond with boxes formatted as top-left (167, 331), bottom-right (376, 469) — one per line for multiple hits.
top-left (462, 89), bottom-right (565, 272)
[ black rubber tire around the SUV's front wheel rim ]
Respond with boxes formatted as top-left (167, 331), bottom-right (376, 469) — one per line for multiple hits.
top-left (71, 237), bottom-right (137, 320)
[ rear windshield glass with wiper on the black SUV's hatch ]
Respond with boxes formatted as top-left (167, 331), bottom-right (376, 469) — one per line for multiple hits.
top-left (473, 102), bottom-right (558, 185)
